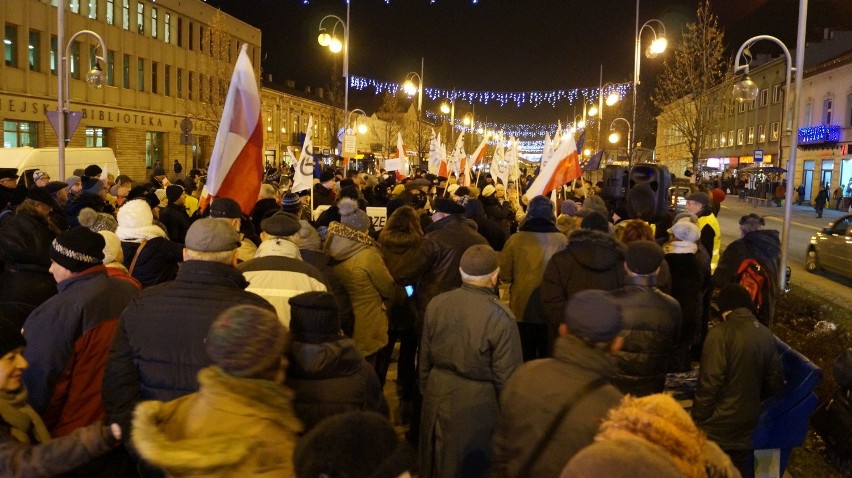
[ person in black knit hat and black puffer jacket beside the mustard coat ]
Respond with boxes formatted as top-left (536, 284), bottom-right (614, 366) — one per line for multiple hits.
top-left (286, 292), bottom-right (388, 433)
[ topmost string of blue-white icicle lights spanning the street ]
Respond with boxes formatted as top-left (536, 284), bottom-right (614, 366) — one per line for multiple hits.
top-left (349, 75), bottom-right (630, 108)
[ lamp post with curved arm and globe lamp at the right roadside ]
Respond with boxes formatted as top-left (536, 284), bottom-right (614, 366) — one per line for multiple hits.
top-left (733, 30), bottom-right (807, 291)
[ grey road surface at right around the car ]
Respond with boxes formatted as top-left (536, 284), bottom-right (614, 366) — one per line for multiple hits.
top-left (718, 196), bottom-right (852, 309)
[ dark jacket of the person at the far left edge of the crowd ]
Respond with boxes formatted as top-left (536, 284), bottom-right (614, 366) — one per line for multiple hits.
top-left (0, 213), bottom-right (56, 325)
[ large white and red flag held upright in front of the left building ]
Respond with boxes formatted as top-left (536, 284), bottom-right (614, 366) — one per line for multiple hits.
top-left (199, 44), bottom-right (263, 214)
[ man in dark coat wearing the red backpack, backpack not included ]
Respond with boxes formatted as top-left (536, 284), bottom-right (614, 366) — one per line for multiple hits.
top-left (713, 213), bottom-right (781, 327)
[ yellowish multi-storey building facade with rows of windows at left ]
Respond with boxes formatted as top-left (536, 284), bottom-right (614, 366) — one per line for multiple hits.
top-left (0, 0), bottom-right (261, 180)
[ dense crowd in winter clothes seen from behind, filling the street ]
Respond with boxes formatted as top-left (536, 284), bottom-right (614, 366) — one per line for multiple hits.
top-left (0, 165), bottom-right (783, 478)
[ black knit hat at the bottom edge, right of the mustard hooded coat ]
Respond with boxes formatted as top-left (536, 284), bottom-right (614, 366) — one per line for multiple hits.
top-left (293, 411), bottom-right (415, 478)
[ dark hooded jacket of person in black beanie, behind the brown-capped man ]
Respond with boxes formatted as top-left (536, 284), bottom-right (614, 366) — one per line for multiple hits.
top-left (541, 229), bottom-right (624, 334)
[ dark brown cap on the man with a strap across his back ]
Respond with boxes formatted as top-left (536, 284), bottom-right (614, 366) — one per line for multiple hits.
top-left (562, 289), bottom-right (622, 342)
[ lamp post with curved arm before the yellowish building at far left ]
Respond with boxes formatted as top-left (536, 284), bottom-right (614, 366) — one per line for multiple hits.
top-left (55, 2), bottom-right (107, 179)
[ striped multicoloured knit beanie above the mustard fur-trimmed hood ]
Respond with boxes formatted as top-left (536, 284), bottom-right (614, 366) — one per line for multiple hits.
top-left (207, 305), bottom-right (287, 379)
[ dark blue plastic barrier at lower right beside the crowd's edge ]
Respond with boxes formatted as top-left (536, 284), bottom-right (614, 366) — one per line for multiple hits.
top-left (753, 337), bottom-right (822, 474)
